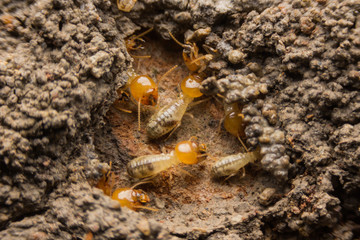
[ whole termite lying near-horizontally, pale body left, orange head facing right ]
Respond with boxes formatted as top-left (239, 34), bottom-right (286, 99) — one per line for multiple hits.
top-left (127, 137), bottom-right (206, 178)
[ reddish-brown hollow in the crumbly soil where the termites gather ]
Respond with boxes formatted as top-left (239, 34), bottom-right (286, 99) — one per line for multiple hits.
top-left (95, 27), bottom-right (282, 230)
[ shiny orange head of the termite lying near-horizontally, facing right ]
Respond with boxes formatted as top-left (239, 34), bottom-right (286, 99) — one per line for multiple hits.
top-left (175, 137), bottom-right (206, 164)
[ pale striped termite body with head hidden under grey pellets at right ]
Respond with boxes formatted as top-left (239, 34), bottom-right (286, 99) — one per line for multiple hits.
top-left (211, 149), bottom-right (260, 179)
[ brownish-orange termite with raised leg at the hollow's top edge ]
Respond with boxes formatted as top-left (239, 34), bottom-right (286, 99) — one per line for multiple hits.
top-left (169, 32), bottom-right (215, 73)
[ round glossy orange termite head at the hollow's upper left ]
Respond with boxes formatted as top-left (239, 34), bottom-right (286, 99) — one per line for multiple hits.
top-left (129, 75), bottom-right (159, 106)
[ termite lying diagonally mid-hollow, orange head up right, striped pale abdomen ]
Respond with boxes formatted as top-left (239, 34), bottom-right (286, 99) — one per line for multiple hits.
top-left (146, 74), bottom-right (202, 139)
